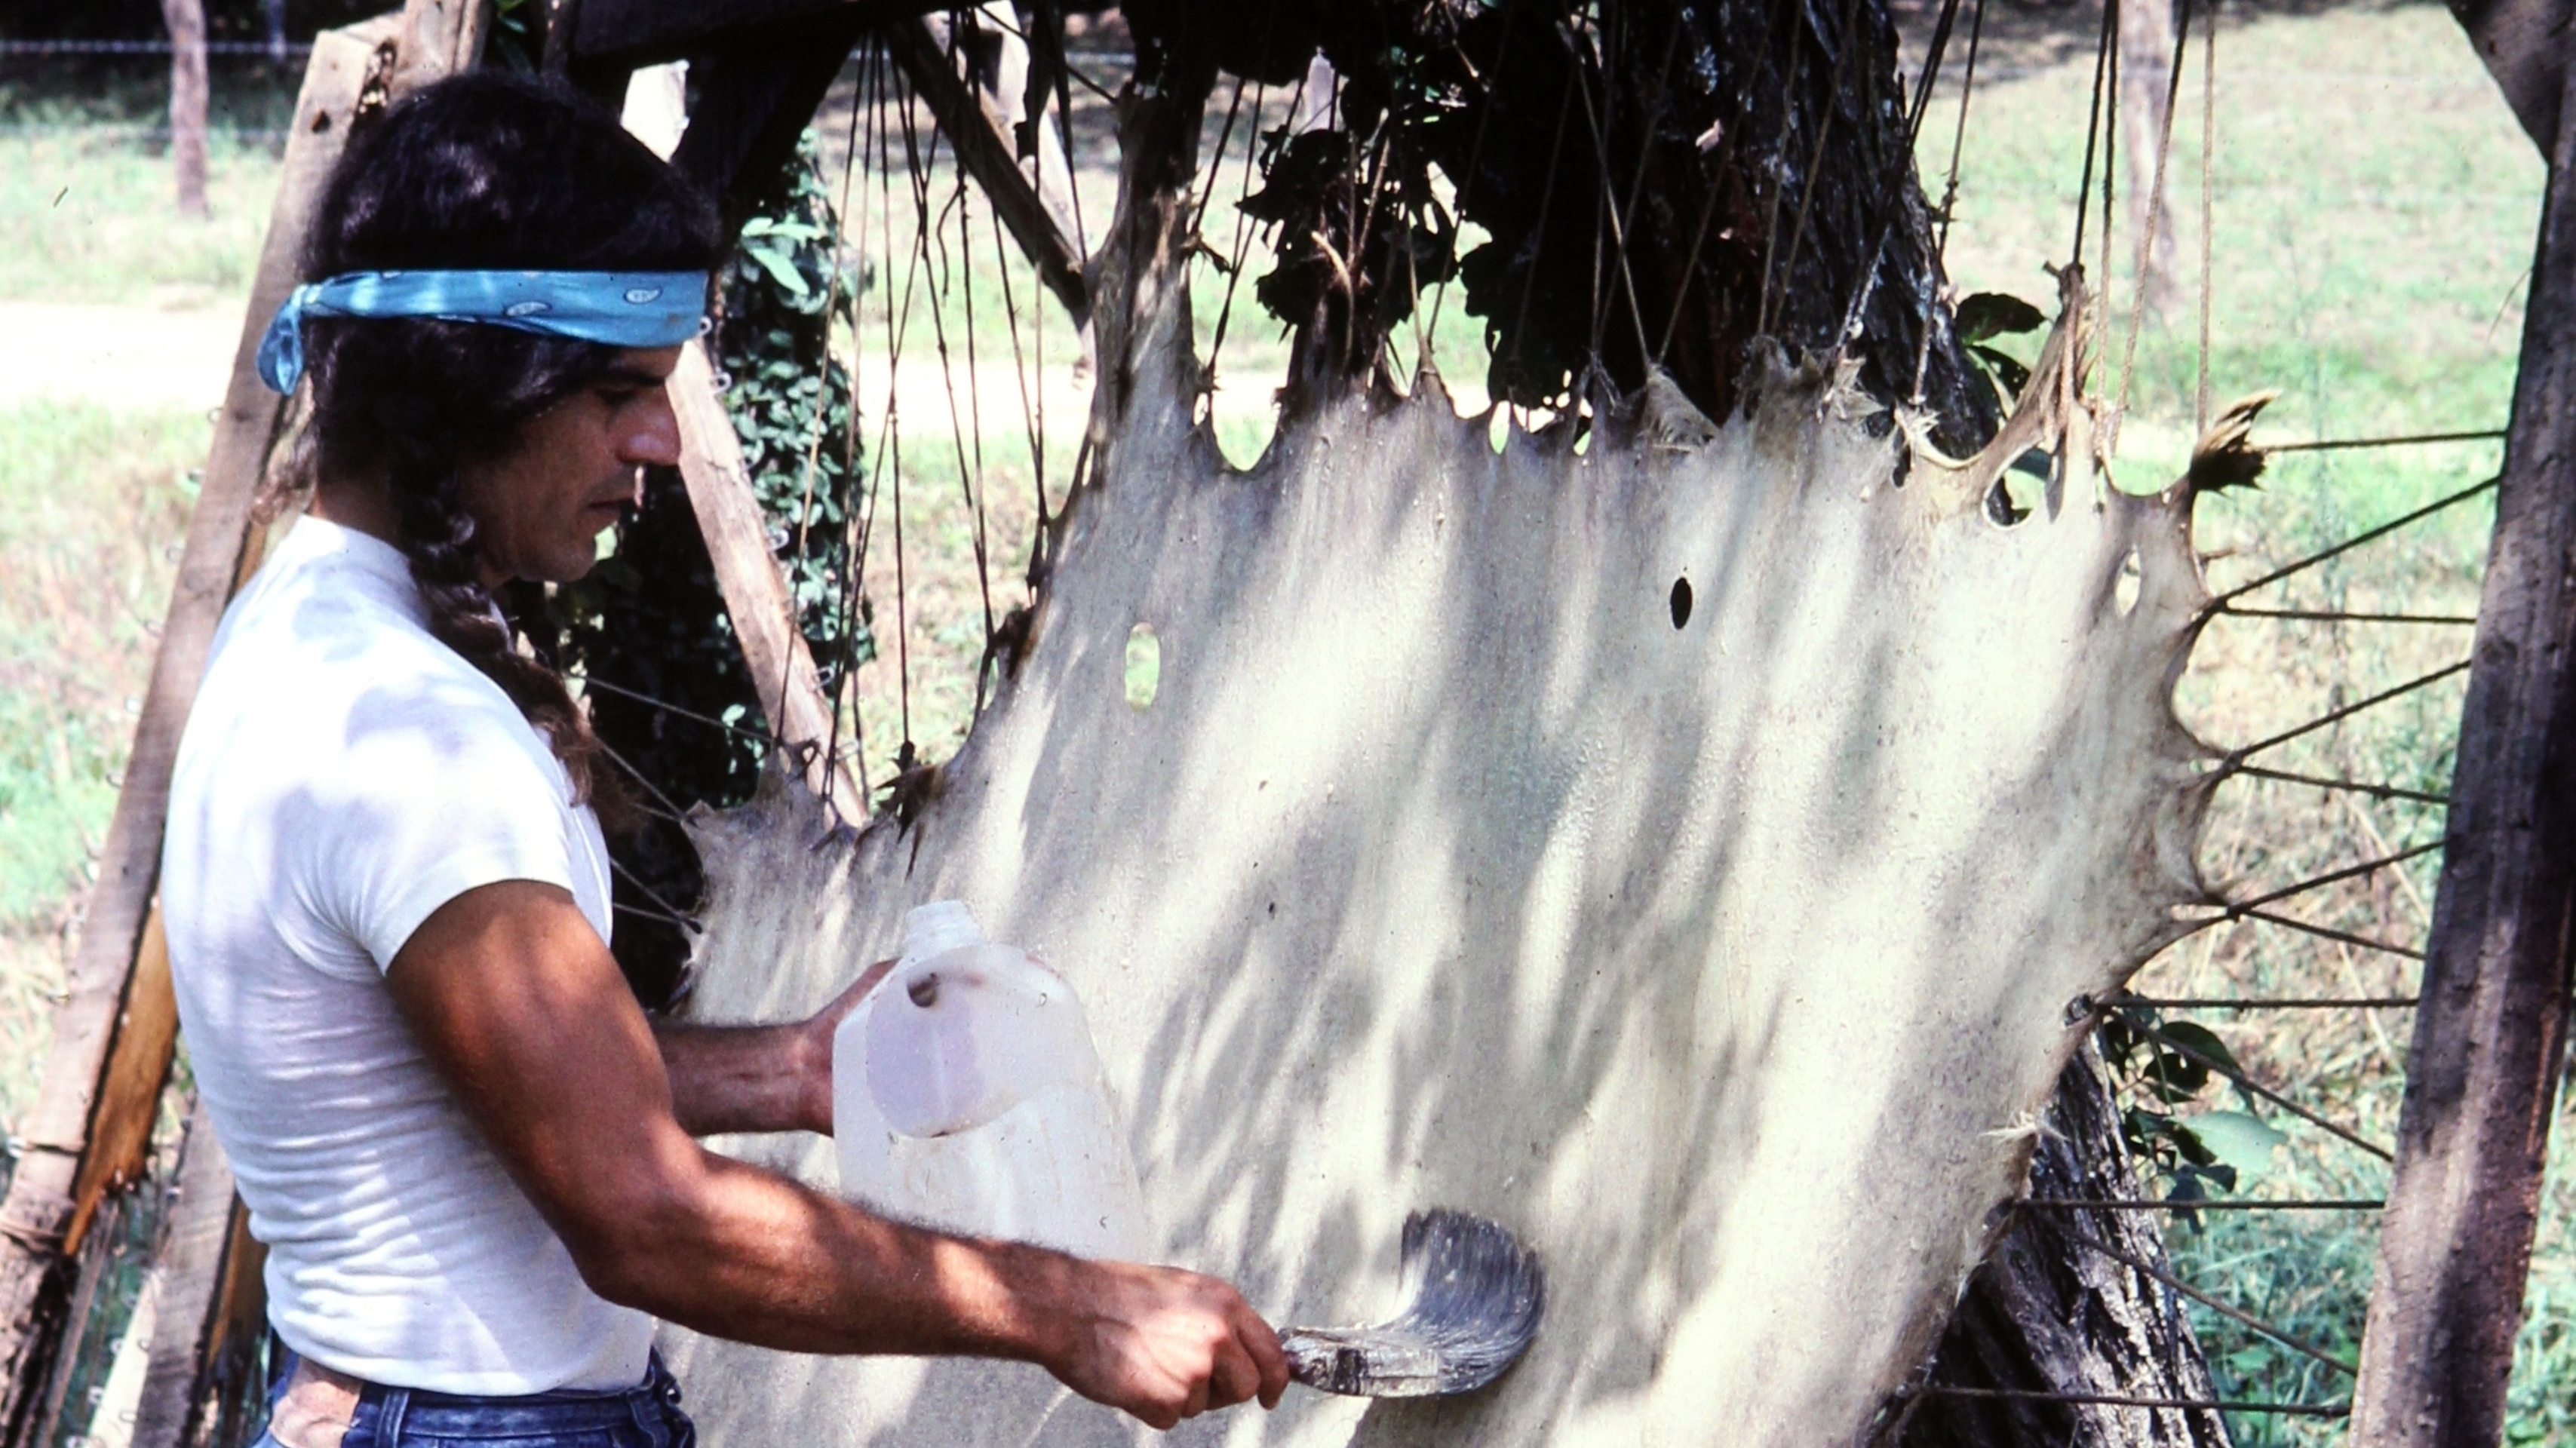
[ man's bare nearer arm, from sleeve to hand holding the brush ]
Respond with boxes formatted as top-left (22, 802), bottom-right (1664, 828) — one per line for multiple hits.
top-left (386, 881), bottom-right (1288, 1428)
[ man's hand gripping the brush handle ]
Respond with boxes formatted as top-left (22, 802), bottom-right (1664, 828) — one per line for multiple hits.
top-left (1045, 1262), bottom-right (1288, 1430)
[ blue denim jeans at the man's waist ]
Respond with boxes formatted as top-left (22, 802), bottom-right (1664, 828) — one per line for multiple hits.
top-left (253, 1353), bottom-right (698, 1448)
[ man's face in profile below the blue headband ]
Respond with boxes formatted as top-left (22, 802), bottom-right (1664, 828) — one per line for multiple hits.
top-left (464, 348), bottom-right (680, 585)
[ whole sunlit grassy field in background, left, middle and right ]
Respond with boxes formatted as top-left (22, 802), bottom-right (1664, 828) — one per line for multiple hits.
top-left (0, 5), bottom-right (2576, 1446)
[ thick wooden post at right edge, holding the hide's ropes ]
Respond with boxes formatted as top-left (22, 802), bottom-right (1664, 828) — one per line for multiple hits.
top-left (2352, 39), bottom-right (2576, 1448)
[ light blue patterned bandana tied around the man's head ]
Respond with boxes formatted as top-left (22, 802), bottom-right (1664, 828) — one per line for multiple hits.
top-left (260, 271), bottom-right (706, 391)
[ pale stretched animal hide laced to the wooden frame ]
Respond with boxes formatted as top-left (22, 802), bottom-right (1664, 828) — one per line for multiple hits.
top-left (649, 265), bottom-right (2210, 1448)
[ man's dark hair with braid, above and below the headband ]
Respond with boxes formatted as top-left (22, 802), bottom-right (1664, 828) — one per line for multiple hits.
top-left (304, 75), bottom-right (724, 824)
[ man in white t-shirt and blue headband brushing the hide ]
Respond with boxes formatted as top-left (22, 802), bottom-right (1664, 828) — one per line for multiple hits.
top-left (162, 77), bottom-right (1288, 1448)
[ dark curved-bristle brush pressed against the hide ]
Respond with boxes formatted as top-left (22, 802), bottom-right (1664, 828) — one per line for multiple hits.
top-left (1280, 1211), bottom-right (1548, 1397)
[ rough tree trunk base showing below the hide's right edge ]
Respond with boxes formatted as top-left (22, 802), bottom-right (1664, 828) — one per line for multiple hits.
top-left (1896, 1046), bottom-right (2228, 1448)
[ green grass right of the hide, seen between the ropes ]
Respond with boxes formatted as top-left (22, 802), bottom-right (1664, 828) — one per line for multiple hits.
top-left (1922, 5), bottom-right (2576, 1448)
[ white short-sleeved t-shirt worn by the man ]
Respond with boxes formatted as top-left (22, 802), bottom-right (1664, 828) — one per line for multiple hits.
top-left (162, 518), bottom-right (654, 1394)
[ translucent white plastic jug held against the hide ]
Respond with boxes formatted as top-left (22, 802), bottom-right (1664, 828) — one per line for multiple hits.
top-left (832, 899), bottom-right (1147, 1257)
